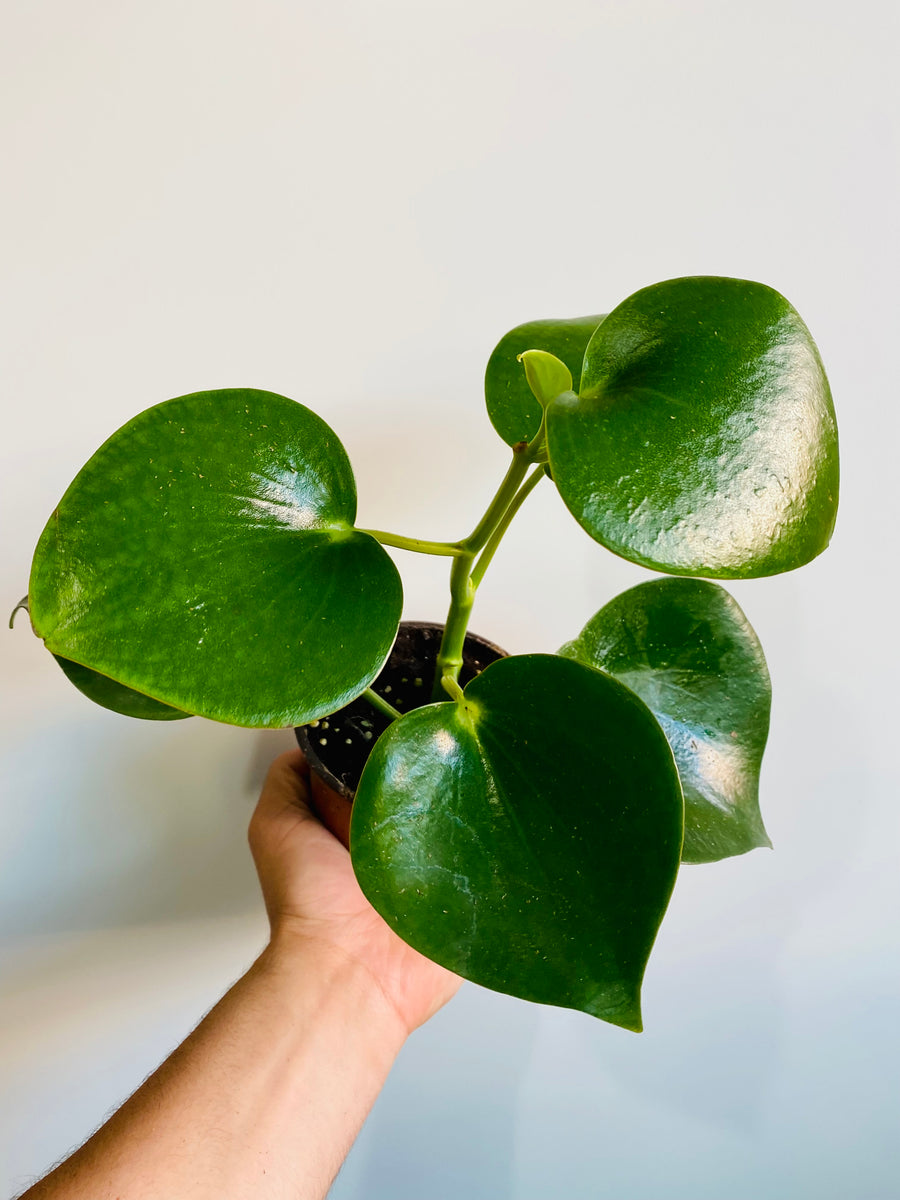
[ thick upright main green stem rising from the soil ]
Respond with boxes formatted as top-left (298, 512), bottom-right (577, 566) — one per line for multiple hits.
top-left (432, 446), bottom-right (544, 701)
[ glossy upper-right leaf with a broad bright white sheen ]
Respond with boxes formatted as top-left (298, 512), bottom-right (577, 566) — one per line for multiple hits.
top-left (547, 277), bottom-right (838, 578)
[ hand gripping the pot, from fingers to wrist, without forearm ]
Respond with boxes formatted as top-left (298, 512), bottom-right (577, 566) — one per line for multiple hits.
top-left (250, 750), bottom-right (462, 1033)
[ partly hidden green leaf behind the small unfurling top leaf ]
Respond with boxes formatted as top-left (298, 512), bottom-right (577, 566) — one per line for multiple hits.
top-left (485, 316), bottom-right (604, 446)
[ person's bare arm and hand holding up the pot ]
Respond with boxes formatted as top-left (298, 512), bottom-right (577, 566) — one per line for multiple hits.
top-left (22, 751), bottom-right (461, 1200)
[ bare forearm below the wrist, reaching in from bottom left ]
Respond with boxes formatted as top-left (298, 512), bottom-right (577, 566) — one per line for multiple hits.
top-left (23, 938), bottom-right (406, 1200)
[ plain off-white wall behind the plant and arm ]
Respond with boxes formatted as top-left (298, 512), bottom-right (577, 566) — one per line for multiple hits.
top-left (0, 0), bottom-right (900, 1200)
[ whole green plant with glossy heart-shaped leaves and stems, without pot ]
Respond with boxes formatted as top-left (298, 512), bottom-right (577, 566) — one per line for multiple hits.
top-left (17, 277), bottom-right (838, 1030)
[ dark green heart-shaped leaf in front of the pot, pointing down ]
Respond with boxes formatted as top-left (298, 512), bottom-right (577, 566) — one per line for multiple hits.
top-left (350, 654), bottom-right (684, 1030)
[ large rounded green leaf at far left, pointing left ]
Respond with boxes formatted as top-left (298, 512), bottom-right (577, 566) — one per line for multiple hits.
top-left (29, 389), bottom-right (402, 727)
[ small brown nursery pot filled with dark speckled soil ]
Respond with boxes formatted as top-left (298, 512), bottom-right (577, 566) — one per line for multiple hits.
top-left (294, 620), bottom-right (506, 845)
